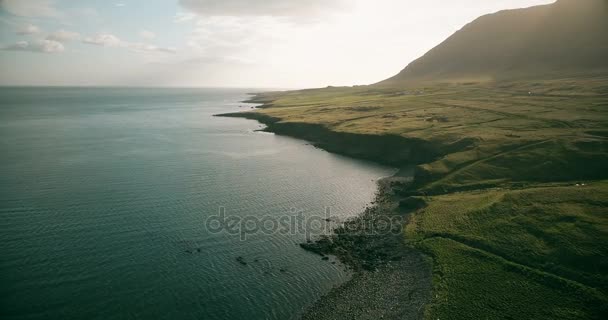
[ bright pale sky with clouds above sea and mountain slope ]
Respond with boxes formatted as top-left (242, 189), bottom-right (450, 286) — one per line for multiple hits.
top-left (0, 0), bottom-right (554, 88)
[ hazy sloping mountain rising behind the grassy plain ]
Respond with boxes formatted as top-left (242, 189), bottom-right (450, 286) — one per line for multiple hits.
top-left (379, 0), bottom-right (608, 85)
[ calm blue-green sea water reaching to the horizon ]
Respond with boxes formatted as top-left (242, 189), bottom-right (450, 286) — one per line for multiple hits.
top-left (0, 88), bottom-right (392, 319)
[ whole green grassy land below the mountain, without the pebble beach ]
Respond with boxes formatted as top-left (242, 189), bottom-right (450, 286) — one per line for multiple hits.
top-left (238, 76), bottom-right (608, 319)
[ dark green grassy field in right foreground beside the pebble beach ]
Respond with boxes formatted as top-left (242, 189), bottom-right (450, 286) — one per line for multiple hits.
top-left (406, 181), bottom-right (608, 319)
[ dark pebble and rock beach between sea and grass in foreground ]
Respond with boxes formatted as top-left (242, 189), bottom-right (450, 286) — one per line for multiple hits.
top-left (301, 176), bottom-right (432, 320)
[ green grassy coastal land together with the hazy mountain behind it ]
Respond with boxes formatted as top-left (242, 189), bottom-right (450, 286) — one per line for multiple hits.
top-left (223, 0), bottom-right (608, 319)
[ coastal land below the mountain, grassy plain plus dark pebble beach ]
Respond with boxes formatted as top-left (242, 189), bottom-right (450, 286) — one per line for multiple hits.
top-left (220, 84), bottom-right (608, 319)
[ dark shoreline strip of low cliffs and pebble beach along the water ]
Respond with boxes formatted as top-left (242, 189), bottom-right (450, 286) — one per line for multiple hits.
top-left (215, 105), bottom-right (438, 319)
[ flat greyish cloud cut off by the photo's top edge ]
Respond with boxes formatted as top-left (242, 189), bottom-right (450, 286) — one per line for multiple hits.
top-left (179, 0), bottom-right (349, 19)
